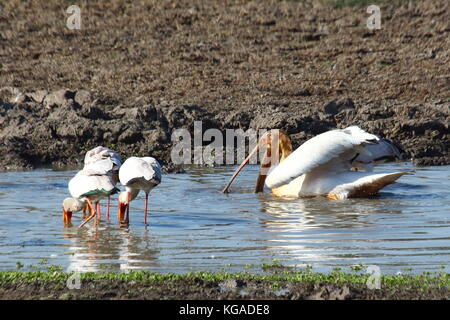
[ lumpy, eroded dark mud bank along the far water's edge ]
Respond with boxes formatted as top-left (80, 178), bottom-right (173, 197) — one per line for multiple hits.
top-left (0, 88), bottom-right (450, 169)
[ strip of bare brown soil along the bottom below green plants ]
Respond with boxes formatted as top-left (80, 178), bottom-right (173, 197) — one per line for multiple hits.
top-left (0, 279), bottom-right (450, 300)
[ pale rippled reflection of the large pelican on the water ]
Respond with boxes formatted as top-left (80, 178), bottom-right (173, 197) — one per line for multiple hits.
top-left (253, 193), bottom-right (402, 266)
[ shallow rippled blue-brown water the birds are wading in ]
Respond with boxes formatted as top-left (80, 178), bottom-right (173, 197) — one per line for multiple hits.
top-left (0, 163), bottom-right (450, 274)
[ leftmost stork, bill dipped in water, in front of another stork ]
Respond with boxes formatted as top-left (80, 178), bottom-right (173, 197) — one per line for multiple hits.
top-left (63, 169), bottom-right (119, 227)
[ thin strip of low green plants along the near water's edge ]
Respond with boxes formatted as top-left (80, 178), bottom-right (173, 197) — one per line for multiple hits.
top-left (0, 267), bottom-right (450, 288)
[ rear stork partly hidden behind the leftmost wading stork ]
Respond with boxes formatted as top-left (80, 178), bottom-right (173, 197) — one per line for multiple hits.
top-left (83, 146), bottom-right (122, 219)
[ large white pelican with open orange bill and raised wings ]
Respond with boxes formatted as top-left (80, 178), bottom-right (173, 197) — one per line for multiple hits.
top-left (223, 126), bottom-right (406, 200)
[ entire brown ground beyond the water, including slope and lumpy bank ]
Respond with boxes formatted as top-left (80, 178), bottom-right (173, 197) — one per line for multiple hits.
top-left (0, 0), bottom-right (450, 169)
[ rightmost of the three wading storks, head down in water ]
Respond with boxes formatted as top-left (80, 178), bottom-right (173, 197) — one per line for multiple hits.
top-left (117, 157), bottom-right (161, 224)
